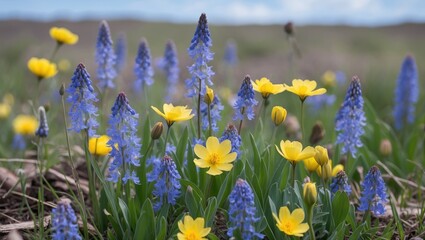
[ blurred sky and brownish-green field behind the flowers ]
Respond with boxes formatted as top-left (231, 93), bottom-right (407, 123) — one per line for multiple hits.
top-left (0, 0), bottom-right (425, 122)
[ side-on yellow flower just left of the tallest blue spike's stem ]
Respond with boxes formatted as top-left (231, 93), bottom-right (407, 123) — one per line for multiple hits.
top-left (151, 103), bottom-right (194, 126)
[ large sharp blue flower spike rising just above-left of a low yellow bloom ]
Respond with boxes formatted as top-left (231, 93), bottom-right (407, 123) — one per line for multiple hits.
top-left (66, 63), bottom-right (99, 136)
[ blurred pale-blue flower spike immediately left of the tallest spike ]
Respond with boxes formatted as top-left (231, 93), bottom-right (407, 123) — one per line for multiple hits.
top-left (158, 40), bottom-right (180, 102)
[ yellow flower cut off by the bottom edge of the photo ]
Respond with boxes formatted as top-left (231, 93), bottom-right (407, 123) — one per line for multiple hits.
top-left (177, 215), bottom-right (211, 240)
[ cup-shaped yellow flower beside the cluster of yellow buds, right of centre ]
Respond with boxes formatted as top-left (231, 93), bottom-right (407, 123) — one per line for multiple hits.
top-left (276, 140), bottom-right (316, 164)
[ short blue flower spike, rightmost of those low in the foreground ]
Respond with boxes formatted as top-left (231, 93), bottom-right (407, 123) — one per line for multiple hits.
top-left (358, 166), bottom-right (388, 215)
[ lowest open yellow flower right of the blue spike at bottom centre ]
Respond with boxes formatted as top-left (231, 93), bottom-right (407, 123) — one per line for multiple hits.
top-left (273, 206), bottom-right (309, 237)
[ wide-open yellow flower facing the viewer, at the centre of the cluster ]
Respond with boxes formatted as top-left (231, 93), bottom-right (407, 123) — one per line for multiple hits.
top-left (193, 137), bottom-right (237, 176)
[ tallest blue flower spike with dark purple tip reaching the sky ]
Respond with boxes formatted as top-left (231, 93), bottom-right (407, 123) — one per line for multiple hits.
top-left (185, 13), bottom-right (214, 97)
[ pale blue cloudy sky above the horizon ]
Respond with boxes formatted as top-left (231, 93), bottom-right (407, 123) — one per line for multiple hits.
top-left (0, 0), bottom-right (425, 26)
